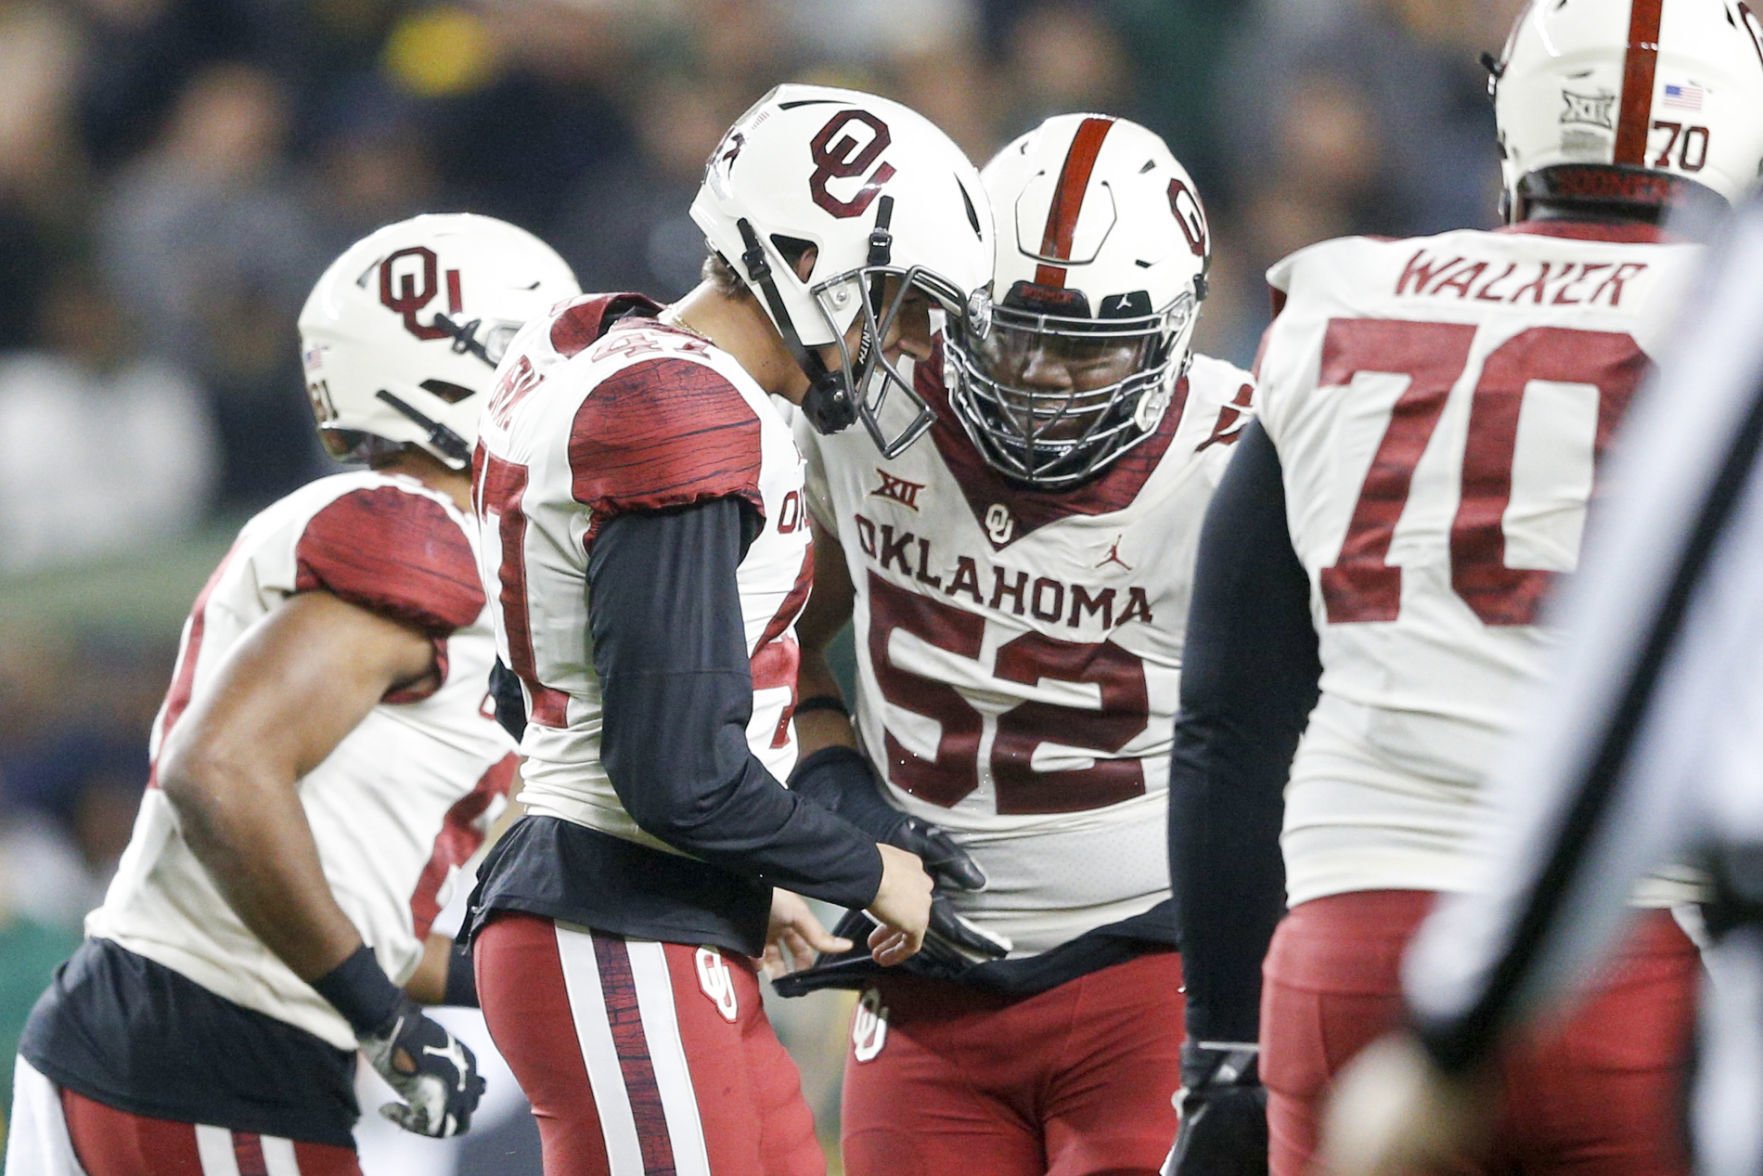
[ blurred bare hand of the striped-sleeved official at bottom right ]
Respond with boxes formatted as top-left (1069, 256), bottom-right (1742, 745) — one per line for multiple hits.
top-left (1317, 1033), bottom-right (1491, 1176)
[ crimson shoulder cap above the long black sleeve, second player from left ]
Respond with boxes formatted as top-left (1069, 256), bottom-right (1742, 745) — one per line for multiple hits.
top-left (569, 356), bottom-right (765, 540)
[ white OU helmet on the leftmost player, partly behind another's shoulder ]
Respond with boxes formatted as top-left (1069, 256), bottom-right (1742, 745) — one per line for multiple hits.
top-left (300, 213), bottom-right (582, 469)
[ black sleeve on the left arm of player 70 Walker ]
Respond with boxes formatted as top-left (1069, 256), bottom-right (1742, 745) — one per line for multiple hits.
top-left (1169, 423), bottom-right (1322, 1042)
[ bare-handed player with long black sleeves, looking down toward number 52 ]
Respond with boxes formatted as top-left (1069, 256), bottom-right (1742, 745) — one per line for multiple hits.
top-left (472, 85), bottom-right (991, 1176)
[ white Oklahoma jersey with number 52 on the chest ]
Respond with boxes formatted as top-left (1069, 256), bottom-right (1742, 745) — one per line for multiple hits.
top-left (797, 356), bottom-right (1252, 956)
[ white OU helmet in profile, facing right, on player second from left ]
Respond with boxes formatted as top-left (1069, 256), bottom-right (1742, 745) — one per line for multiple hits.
top-left (691, 85), bottom-right (993, 457)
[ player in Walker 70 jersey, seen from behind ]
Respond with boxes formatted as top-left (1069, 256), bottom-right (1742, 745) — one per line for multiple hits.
top-left (1169, 0), bottom-right (1763, 1176)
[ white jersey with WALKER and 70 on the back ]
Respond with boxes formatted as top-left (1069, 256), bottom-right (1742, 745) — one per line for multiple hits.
top-left (1259, 222), bottom-right (1698, 904)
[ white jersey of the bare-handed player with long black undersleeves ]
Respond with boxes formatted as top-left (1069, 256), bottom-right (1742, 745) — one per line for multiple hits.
top-left (472, 296), bottom-right (813, 852)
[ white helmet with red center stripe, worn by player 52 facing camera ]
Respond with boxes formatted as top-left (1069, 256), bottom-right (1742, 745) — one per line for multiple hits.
top-left (947, 115), bottom-right (1211, 488)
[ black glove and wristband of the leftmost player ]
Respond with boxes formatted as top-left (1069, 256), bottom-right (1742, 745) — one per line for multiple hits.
top-left (312, 947), bottom-right (483, 1139)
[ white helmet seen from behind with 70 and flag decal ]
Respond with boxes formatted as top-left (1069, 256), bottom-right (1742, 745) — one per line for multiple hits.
top-left (1488, 0), bottom-right (1763, 220)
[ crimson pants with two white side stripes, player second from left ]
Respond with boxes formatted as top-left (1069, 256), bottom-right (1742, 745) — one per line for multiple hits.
top-left (472, 913), bottom-right (825, 1176)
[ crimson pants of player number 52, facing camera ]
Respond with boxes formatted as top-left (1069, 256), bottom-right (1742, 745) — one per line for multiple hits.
top-left (843, 952), bottom-right (1183, 1176)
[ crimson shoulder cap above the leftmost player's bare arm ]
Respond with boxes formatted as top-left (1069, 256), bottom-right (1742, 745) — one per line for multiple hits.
top-left (294, 487), bottom-right (485, 636)
